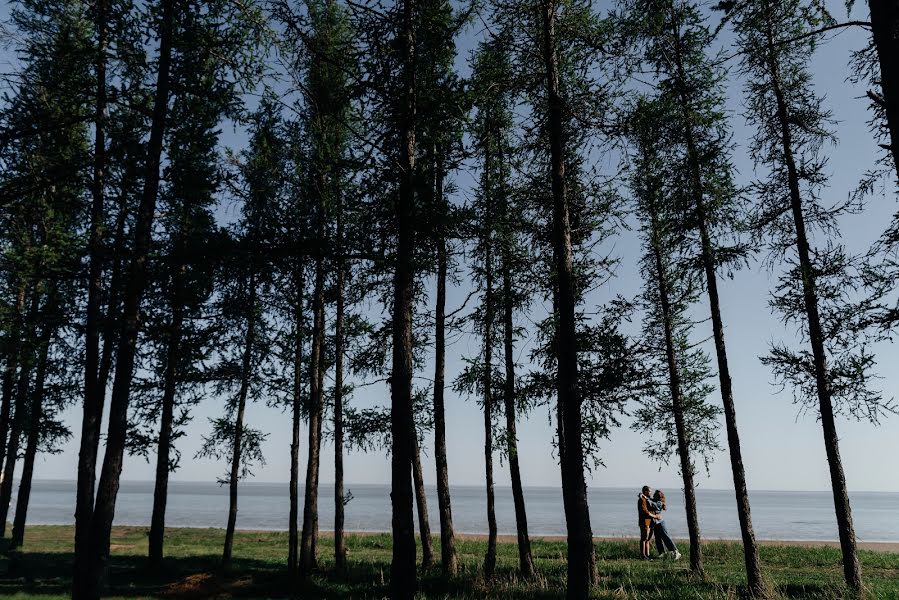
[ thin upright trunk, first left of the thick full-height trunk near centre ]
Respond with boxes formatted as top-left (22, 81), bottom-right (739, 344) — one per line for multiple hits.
top-left (334, 209), bottom-right (347, 573)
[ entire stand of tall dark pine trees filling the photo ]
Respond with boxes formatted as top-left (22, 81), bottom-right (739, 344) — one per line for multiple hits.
top-left (0, 0), bottom-right (899, 600)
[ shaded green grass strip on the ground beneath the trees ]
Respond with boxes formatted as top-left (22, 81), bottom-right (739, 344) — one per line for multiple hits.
top-left (0, 526), bottom-right (899, 600)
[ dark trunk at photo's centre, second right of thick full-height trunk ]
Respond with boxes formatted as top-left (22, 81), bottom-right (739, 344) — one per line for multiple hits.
top-left (434, 159), bottom-right (459, 576)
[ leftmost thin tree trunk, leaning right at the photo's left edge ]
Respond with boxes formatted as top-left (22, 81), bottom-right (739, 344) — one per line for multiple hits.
top-left (0, 292), bottom-right (40, 537)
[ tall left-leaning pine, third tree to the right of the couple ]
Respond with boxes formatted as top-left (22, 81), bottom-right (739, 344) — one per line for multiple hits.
top-left (730, 0), bottom-right (896, 590)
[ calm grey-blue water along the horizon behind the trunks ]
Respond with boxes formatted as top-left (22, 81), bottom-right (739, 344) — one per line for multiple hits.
top-left (12, 481), bottom-right (899, 542)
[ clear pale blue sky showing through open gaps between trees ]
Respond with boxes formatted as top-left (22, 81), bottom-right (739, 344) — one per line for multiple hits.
top-left (14, 0), bottom-right (899, 492)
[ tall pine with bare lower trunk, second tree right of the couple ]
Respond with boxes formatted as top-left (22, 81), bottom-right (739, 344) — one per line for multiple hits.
top-left (628, 0), bottom-right (765, 596)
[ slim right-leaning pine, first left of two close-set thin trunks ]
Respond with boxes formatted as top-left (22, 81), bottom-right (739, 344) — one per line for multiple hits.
top-left (198, 96), bottom-right (287, 569)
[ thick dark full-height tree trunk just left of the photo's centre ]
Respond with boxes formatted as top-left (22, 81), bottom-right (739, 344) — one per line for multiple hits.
top-left (390, 0), bottom-right (418, 600)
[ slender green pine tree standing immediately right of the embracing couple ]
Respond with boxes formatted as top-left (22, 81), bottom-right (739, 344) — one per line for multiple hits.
top-left (631, 96), bottom-right (720, 573)
